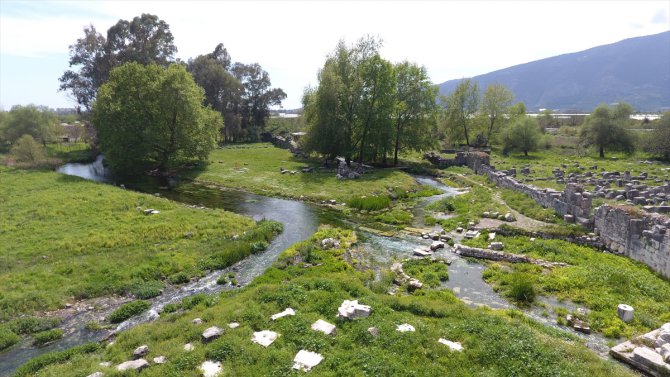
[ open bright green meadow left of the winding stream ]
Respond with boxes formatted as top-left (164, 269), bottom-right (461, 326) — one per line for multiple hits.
top-left (0, 166), bottom-right (281, 343)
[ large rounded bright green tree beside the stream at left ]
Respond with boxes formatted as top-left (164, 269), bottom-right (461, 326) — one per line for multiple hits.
top-left (93, 63), bottom-right (222, 173)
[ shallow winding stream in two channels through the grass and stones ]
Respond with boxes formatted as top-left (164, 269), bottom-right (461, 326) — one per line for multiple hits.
top-left (0, 156), bottom-right (609, 376)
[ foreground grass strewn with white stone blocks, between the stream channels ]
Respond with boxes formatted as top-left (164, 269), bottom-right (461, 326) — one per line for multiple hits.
top-left (26, 228), bottom-right (633, 376)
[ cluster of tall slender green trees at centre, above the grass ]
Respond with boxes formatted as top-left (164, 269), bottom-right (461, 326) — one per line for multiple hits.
top-left (303, 38), bottom-right (437, 164)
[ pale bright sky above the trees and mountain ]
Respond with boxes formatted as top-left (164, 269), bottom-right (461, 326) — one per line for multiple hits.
top-left (0, 0), bottom-right (670, 110)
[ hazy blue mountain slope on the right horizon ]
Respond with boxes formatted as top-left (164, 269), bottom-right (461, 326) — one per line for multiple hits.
top-left (440, 31), bottom-right (670, 112)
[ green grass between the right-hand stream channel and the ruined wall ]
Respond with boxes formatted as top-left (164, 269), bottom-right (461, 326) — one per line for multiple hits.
top-left (464, 237), bottom-right (670, 337)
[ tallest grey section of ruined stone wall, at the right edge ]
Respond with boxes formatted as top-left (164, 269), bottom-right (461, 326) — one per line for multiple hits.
top-left (594, 205), bottom-right (670, 279)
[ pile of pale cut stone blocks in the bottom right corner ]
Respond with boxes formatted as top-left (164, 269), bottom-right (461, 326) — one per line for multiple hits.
top-left (610, 322), bottom-right (670, 377)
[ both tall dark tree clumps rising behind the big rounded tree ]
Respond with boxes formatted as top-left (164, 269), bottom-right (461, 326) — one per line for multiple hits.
top-left (59, 14), bottom-right (286, 141)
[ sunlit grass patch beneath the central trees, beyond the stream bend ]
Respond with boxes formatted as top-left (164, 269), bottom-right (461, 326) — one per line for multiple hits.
top-left (190, 144), bottom-right (418, 202)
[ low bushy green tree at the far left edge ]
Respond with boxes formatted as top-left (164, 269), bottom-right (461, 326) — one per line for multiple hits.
top-left (2, 105), bottom-right (59, 145)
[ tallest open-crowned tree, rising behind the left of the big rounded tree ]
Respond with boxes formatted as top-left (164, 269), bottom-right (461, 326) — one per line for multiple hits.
top-left (59, 14), bottom-right (177, 110)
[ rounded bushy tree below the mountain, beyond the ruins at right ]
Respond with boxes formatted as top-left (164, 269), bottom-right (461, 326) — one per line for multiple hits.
top-left (580, 103), bottom-right (635, 158)
